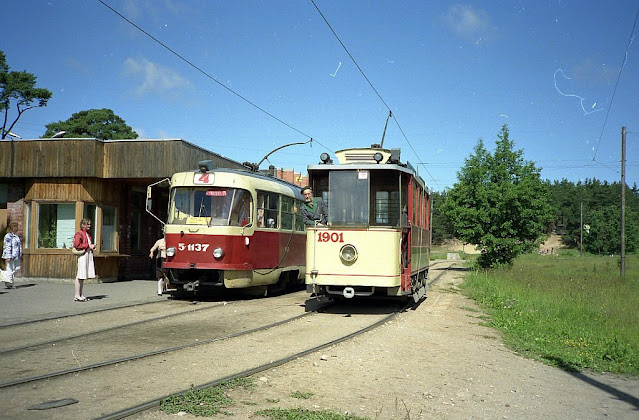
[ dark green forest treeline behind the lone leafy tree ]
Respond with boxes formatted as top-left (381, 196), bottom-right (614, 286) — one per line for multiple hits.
top-left (431, 179), bottom-right (639, 255)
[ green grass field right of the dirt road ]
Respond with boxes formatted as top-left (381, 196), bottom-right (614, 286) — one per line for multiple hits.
top-left (462, 251), bottom-right (639, 375)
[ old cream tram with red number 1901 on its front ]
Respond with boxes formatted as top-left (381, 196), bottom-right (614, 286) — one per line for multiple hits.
top-left (305, 145), bottom-right (430, 302)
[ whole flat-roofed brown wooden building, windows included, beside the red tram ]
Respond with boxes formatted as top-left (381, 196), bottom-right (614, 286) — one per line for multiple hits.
top-left (0, 139), bottom-right (243, 281)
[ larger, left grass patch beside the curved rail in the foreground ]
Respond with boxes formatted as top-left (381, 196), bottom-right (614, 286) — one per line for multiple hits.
top-left (160, 378), bottom-right (256, 417)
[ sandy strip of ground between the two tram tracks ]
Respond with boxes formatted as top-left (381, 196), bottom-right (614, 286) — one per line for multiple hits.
top-left (0, 292), bottom-right (311, 389)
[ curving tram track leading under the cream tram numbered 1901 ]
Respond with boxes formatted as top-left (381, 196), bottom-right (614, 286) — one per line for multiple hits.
top-left (0, 260), bottom-right (460, 418)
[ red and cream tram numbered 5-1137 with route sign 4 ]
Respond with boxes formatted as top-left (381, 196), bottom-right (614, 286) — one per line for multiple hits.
top-left (147, 161), bottom-right (306, 293)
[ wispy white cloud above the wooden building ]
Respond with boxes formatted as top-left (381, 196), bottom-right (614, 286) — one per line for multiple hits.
top-left (124, 58), bottom-right (191, 95)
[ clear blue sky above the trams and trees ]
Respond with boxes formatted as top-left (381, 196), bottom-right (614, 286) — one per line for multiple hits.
top-left (0, 0), bottom-right (639, 191)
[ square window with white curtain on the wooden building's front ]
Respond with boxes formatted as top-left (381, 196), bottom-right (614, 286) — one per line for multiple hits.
top-left (37, 203), bottom-right (75, 248)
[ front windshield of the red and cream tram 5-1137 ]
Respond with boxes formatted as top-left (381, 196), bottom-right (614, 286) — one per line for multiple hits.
top-left (168, 187), bottom-right (253, 226)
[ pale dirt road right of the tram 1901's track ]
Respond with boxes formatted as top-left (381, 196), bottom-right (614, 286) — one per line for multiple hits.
top-left (137, 260), bottom-right (639, 419)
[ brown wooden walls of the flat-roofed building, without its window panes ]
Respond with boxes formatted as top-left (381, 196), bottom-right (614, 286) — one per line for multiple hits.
top-left (0, 139), bottom-right (248, 280)
